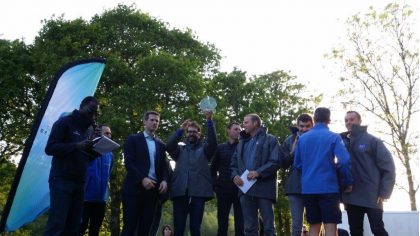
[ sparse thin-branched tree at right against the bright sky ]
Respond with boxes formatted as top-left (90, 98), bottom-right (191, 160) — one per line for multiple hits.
top-left (331, 3), bottom-right (419, 211)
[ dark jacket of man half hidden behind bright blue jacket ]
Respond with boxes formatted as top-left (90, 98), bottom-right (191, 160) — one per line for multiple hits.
top-left (279, 134), bottom-right (302, 195)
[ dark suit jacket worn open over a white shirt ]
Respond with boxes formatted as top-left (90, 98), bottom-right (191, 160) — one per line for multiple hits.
top-left (122, 132), bottom-right (169, 195)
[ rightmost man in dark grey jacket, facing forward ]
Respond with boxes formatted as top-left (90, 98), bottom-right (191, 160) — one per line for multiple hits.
top-left (341, 111), bottom-right (395, 236)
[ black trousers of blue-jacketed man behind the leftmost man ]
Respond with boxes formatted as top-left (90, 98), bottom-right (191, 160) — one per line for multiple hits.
top-left (80, 202), bottom-right (106, 236)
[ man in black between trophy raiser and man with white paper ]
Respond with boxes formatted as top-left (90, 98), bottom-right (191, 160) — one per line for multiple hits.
top-left (210, 122), bottom-right (244, 236)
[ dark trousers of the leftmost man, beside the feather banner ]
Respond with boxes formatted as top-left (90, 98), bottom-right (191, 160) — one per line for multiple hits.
top-left (45, 177), bottom-right (84, 236)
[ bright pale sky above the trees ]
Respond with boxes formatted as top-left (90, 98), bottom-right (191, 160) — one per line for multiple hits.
top-left (0, 0), bottom-right (418, 210)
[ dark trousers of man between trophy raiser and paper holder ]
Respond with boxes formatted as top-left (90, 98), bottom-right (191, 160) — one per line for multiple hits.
top-left (216, 191), bottom-right (244, 236)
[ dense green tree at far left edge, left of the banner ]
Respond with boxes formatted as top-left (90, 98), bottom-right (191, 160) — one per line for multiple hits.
top-left (0, 40), bottom-right (39, 163)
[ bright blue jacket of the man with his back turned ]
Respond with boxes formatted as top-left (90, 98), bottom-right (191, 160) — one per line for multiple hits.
top-left (293, 123), bottom-right (353, 194)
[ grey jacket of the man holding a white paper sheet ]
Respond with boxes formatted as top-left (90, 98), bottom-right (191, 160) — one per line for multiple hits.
top-left (231, 127), bottom-right (279, 202)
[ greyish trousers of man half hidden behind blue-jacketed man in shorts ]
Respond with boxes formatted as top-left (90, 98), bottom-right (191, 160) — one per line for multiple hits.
top-left (287, 194), bottom-right (305, 236)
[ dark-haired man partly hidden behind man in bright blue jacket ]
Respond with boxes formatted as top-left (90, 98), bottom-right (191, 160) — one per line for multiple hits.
top-left (281, 114), bottom-right (314, 236)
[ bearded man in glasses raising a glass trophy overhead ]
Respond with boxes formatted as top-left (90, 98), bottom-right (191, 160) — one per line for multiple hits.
top-left (167, 111), bottom-right (217, 236)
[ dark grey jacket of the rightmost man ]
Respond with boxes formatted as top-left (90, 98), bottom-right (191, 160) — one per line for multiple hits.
top-left (342, 125), bottom-right (395, 209)
